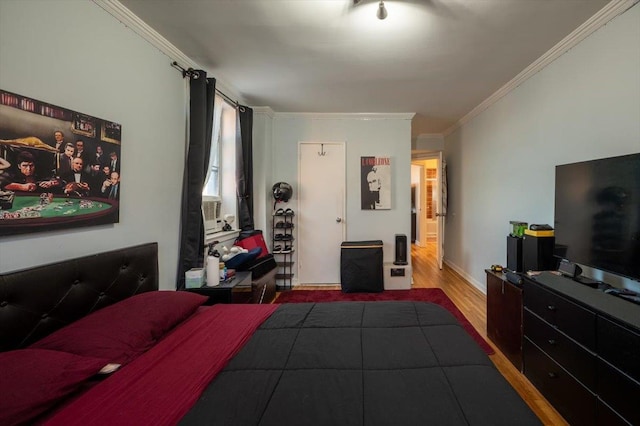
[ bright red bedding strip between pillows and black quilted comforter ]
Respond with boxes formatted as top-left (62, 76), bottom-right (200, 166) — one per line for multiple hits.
top-left (45, 305), bottom-right (278, 426)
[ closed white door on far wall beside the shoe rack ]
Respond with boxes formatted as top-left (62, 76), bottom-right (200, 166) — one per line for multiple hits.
top-left (295, 142), bottom-right (346, 284)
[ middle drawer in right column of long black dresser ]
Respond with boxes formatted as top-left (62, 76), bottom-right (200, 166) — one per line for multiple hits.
top-left (597, 360), bottom-right (640, 425)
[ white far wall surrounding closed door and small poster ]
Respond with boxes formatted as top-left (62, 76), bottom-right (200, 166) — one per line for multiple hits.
top-left (254, 113), bottom-right (411, 282)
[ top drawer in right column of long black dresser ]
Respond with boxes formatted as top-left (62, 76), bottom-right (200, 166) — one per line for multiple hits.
top-left (597, 316), bottom-right (640, 382)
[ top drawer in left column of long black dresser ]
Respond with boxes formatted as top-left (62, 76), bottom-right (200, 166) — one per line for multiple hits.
top-left (523, 280), bottom-right (596, 351)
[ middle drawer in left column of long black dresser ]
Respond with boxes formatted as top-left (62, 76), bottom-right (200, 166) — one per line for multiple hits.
top-left (524, 309), bottom-right (597, 390)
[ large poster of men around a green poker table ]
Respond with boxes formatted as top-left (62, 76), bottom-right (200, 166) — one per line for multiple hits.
top-left (0, 90), bottom-right (121, 237)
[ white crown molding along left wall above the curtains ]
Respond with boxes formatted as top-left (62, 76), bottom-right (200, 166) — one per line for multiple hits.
top-left (92, 0), bottom-right (244, 103)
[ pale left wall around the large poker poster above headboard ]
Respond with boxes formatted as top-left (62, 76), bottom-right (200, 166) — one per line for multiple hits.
top-left (0, 0), bottom-right (186, 289)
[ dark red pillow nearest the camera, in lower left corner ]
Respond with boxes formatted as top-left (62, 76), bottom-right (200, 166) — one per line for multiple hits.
top-left (0, 349), bottom-right (107, 425)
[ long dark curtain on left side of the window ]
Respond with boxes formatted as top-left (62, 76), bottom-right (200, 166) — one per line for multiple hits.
top-left (176, 70), bottom-right (216, 289)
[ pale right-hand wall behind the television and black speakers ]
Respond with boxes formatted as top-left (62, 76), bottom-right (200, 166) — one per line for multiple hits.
top-left (445, 4), bottom-right (640, 290)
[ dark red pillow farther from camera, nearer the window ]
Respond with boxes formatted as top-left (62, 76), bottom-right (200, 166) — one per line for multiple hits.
top-left (30, 291), bottom-right (207, 365)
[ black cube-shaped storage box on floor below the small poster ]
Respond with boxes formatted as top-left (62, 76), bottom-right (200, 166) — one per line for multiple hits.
top-left (340, 240), bottom-right (384, 293)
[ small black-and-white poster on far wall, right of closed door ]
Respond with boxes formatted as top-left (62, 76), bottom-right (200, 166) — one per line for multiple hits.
top-left (360, 157), bottom-right (391, 210)
